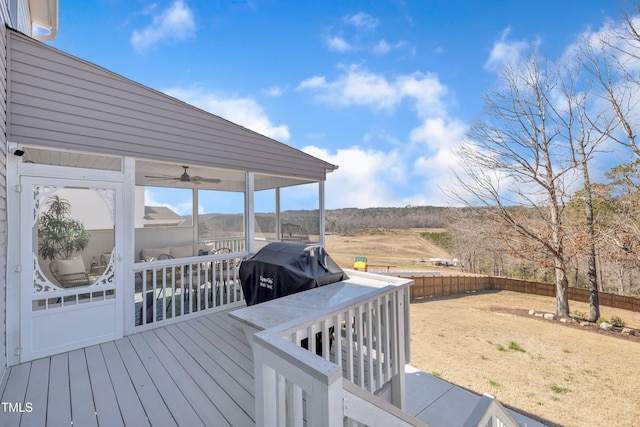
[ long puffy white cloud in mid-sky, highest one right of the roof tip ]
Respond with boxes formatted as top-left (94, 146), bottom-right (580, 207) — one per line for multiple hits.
top-left (297, 65), bottom-right (447, 116)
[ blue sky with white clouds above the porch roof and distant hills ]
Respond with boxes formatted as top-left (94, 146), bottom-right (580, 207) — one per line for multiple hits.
top-left (50, 0), bottom-right (622, 209)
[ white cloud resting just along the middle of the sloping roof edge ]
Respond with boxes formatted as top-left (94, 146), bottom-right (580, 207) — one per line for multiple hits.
top-left (164, 88), bottom-right (290, 141)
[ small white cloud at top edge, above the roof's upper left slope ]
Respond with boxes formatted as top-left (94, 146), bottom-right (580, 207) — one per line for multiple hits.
top-left (131, 0), bottom-right (196, 51)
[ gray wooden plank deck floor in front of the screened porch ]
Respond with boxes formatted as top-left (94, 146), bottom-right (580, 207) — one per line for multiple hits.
top-left (0, 311), bottom-right (255, 427)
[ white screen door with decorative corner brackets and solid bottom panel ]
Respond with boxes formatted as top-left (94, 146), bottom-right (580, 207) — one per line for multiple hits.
top-left (20, 176), bottom-right (124, 362)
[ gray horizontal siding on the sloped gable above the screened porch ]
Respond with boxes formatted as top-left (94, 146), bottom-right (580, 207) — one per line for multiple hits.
top-left (8, 31), bottom-right (333, 180)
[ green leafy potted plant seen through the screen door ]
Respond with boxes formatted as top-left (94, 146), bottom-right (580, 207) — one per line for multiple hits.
top-left (38, 195), bottom-right (91, 261)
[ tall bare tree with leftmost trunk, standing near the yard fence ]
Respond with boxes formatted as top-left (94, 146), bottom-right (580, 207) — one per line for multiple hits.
top-left (451, 54), bottom-right (575, 316)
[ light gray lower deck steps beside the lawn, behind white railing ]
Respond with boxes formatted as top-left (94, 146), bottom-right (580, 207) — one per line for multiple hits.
top-left (405, 365), bottom-right (545, 427)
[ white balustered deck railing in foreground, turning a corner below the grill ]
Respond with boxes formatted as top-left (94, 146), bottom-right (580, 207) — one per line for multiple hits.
top-left (253, 281), bottom-right (412, 426)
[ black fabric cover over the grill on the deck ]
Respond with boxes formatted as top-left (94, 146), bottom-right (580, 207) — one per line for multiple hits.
top-left (239, 242), bottom-right (347, 306)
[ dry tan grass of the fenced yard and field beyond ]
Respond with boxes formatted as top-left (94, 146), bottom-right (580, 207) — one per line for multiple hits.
top-left (326, 230), bottom-right (640, 427)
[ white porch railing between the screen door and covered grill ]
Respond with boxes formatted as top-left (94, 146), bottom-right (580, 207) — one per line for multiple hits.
top-left (133, 253), bottom-right (247, 327)
